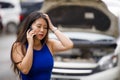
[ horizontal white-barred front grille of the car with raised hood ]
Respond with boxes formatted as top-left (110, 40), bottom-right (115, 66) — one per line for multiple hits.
top-left (52, 62), bottom-right (97, 76)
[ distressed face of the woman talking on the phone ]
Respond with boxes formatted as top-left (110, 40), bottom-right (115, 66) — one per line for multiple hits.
top-left (32, 18), bottom-right (48, 40)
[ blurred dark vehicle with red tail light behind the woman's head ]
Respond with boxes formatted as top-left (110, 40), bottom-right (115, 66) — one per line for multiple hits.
top-left (20, 0), bottom-right (44, 23)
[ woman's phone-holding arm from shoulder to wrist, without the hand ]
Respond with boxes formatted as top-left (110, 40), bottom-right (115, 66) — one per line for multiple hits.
top-left (12, 44), bottom-right (33, 74)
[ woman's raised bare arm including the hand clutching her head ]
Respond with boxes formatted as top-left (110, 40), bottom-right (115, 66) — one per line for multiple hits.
top-left (46, 14), bottom-right (73, 52)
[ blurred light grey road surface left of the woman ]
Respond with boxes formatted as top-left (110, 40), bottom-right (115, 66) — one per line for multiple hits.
top-left (0, 35), bottom-right (18, 80)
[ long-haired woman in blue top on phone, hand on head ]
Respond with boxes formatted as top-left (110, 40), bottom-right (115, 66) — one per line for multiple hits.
top-left (11, 12), bottom-right (73, 80)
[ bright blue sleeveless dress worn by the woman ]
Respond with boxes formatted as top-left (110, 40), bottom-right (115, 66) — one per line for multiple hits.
top-left (20, 44), bottom-right (53, 80)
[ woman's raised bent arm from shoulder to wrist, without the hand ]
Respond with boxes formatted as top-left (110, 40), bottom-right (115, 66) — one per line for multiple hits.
top-left (53, 26), bottom-right (73, 51)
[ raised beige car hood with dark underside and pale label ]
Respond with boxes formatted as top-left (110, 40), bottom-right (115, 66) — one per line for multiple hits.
top-left (40, 0), bottom-right (119, 38)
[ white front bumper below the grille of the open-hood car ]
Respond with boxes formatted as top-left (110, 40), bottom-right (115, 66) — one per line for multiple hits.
top-left (52, 67), bottom-right (120, 80)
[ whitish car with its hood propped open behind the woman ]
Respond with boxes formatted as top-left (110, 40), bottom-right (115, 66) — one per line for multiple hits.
top-left (40, 0), bottom-right (120, 80)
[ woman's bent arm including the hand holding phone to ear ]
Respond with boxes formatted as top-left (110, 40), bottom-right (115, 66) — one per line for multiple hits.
top-left (12, 31), bottom-right (34, 74)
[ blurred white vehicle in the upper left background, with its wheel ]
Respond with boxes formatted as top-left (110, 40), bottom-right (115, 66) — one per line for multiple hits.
top-left (0, 0), bottom-right (21, 33)
